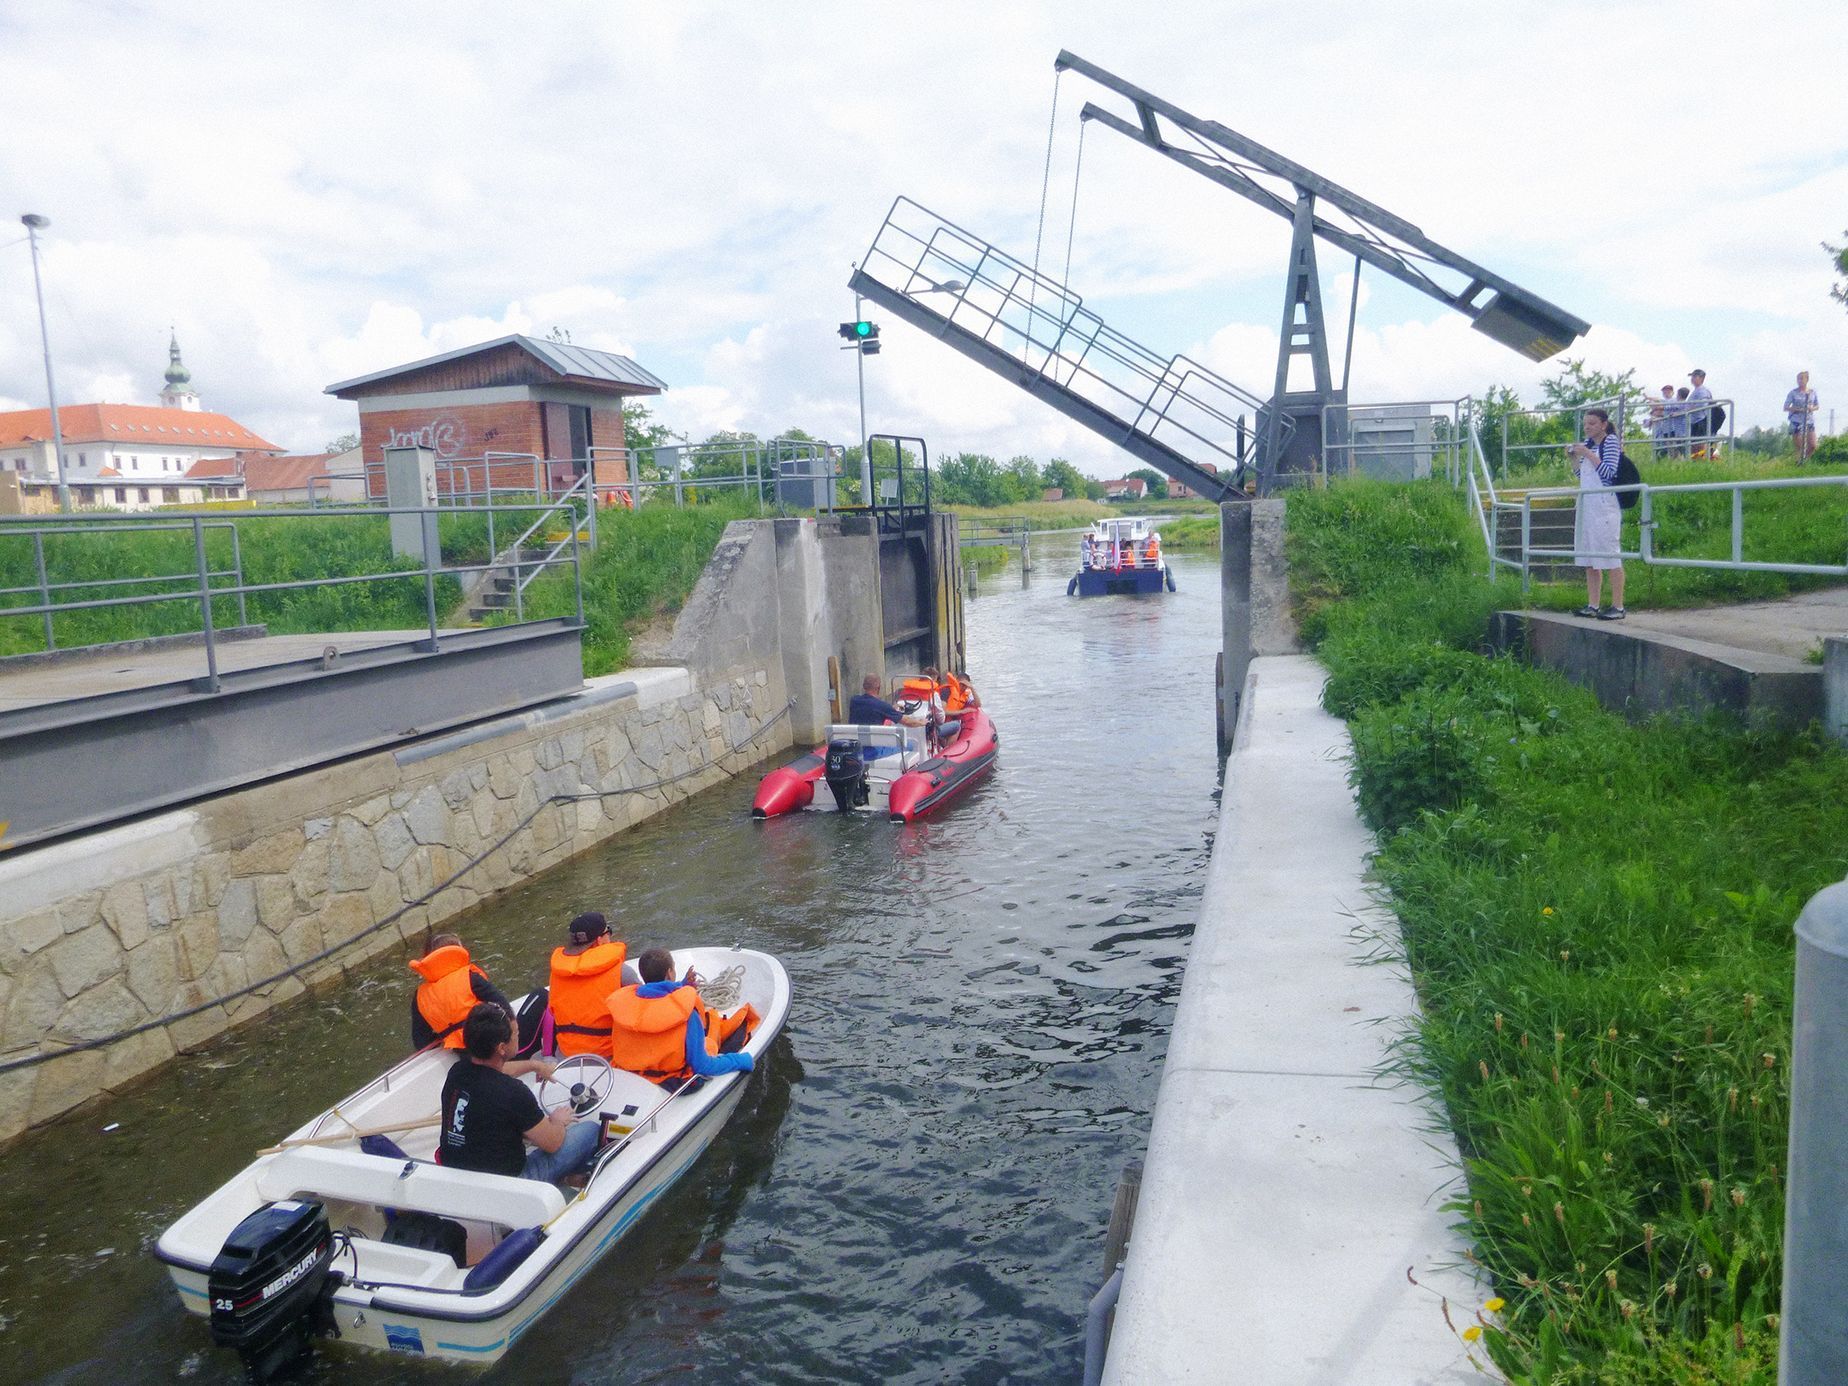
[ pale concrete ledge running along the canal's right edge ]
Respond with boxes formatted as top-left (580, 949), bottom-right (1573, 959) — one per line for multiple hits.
top-left (1103, 656), bottom-right (1488, 1386)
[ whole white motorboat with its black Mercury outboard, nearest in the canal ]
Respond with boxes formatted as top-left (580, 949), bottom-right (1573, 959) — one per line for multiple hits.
top-left (155, 948), bottom-right (789, 1380)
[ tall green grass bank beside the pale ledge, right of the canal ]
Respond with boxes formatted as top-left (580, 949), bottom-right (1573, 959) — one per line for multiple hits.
top-left (1288, 482), bottom-right (1848, 1386)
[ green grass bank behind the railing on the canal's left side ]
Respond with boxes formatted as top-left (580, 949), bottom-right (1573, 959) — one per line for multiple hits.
top-left (0, 505), bottom-right (752, 675)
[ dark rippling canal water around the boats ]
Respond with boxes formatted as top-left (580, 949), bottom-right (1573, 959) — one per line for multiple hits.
top-left (0, 536), bottom-right (1220, 1382)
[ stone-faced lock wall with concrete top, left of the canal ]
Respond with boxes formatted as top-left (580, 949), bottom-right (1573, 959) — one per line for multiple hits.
top-left (0, 517), bottom-right (912, 1144)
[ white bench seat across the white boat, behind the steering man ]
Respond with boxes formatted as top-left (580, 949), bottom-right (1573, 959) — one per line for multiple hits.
top-left (257, 1146), bottom-right (565, 1227)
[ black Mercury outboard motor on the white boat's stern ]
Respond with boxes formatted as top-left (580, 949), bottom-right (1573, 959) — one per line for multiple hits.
top-left (207, 1199), bottom-right (340, 1382)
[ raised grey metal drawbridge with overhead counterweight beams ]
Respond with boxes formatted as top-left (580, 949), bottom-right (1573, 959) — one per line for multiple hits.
top-left (850, 52), bottom-right (1589, 501)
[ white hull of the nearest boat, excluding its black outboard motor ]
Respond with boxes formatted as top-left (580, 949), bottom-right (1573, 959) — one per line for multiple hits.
top-left (157, 948), bottom-right (789, 1366)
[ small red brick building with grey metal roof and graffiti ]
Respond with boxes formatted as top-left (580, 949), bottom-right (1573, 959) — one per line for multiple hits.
top-left (327, 334), bottom-right (667, 493)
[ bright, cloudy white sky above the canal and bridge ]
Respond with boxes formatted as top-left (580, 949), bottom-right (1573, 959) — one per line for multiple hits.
top-left (0, 0), bottom-right (1848, 477)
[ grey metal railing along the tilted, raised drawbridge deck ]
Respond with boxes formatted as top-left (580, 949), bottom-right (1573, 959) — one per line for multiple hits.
top-left (859, 198), bottom-right (1290, 475)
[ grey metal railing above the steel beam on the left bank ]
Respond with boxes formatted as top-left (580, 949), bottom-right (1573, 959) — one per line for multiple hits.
top-left (0, 502), bottom-right (593, 693)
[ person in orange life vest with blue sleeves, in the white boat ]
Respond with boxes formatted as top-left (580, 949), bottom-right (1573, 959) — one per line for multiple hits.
top-left (610, 948), bottom-right (758, 1092)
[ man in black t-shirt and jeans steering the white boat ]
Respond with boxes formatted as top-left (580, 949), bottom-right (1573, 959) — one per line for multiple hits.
top-left (436, 1002), bottom-right (599, 1181)
